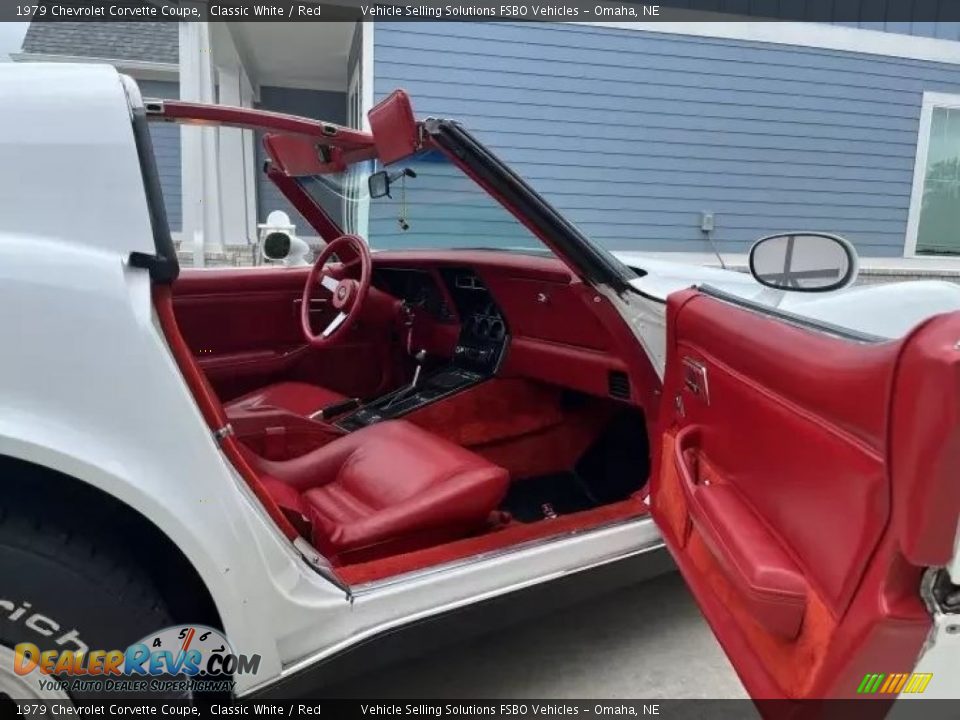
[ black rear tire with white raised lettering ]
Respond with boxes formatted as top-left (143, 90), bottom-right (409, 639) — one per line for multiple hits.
top-left (0, 490), bottom-right (184, 699)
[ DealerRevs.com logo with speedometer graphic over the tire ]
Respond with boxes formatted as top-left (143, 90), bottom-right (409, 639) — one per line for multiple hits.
top-left (13, 625), bottom-right (260, 692)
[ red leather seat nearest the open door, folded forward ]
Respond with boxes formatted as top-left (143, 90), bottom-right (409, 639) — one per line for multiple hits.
top-left (240, 420), bottom-right (509, 565)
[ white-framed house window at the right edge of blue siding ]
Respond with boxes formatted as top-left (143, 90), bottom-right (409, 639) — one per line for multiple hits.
top-left (905, 93), bottom-right (960, 256)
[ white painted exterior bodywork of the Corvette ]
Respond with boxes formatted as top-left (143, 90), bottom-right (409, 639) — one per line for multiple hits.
top-left (0, 64), bottom-right (960, 695)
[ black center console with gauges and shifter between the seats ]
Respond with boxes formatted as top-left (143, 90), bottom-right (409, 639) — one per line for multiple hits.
top-left (335, 268), bottom-right (509, 432)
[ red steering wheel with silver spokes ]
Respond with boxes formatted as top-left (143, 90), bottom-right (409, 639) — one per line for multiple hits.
top-left (300, 235), bottom-right (371, 347)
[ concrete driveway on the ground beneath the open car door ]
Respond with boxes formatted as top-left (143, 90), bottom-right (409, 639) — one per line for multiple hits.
top-left (330, 573), bottom-right (747, 699)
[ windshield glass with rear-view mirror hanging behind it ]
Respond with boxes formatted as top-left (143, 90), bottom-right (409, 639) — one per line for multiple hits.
top-left (298, 150), bottom-right (550, 254)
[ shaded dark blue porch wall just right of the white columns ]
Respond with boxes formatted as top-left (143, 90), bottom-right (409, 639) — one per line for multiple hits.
top-left (254, 86), bottom-right (347, 235)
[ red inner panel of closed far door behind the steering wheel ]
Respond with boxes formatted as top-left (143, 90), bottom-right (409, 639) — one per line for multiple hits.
top-left (173, 267), bottom-right (399, 401)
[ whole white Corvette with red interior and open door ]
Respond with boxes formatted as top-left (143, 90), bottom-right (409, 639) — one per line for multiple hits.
top-left (0, 64), bottom-right (960, 699)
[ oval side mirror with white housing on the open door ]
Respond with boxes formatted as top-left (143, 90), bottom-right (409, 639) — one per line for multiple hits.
top-left (750, 232), bottom-right (860, 292)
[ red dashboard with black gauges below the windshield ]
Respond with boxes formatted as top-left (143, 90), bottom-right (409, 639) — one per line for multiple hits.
top-left (373, 250), bottom-right (632, 400)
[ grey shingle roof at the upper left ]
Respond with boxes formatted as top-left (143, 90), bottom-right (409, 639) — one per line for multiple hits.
top-left (23, 21), bottom-right (179, 63)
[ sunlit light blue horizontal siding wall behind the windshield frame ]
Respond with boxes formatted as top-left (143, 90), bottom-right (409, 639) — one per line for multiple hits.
top-left (374, 23), bottom-right (960, 256)
